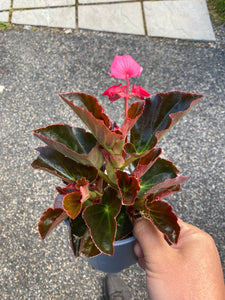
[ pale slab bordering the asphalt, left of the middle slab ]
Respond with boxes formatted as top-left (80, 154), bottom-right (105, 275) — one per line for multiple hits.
top-left (12, 7), bottom-right (76, 28)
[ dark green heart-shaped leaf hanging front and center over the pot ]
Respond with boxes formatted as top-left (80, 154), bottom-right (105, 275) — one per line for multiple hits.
top-left (83, 187), bottom-right (121, 255)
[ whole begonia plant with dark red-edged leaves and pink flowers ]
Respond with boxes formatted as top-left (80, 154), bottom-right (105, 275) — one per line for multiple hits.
top-left (32, 55), bottom-right (203, 272)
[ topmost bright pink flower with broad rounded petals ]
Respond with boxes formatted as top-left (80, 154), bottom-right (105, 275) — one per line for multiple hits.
top-left (109, 55), bottom-right (143, 79)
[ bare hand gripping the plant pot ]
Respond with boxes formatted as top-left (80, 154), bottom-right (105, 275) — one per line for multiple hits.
top-left (134, 218), bottom-right (225, 300)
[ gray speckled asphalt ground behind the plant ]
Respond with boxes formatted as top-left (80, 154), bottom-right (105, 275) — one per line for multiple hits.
top-left (0, 26), bottom-right (225, 300)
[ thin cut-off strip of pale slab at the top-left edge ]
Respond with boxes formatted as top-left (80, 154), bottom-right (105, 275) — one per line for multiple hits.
top-left (13, 0), bottom-right (76, 8)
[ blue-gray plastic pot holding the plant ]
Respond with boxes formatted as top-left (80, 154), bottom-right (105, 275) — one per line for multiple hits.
top-left (88, 236), bottom-right (137, 273)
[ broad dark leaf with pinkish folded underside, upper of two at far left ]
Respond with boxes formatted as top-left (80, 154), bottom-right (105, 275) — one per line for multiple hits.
top-left (34, 125), bottom-right (103, 168)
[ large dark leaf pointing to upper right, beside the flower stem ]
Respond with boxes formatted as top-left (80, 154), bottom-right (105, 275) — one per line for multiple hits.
top-left (131, 91), bottom-right (203, 153)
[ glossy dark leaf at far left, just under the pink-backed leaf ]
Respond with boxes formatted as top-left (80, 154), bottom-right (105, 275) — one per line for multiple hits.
top-left (31, 146), bottom-right (98, 182)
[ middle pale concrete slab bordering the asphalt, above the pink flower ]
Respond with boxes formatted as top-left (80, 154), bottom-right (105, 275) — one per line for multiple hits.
top-left (78, 2), bottom-right (145, 35)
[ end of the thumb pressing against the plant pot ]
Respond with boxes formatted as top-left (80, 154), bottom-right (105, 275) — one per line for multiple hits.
top-left (133, 218), bottom-right (170, 259)
